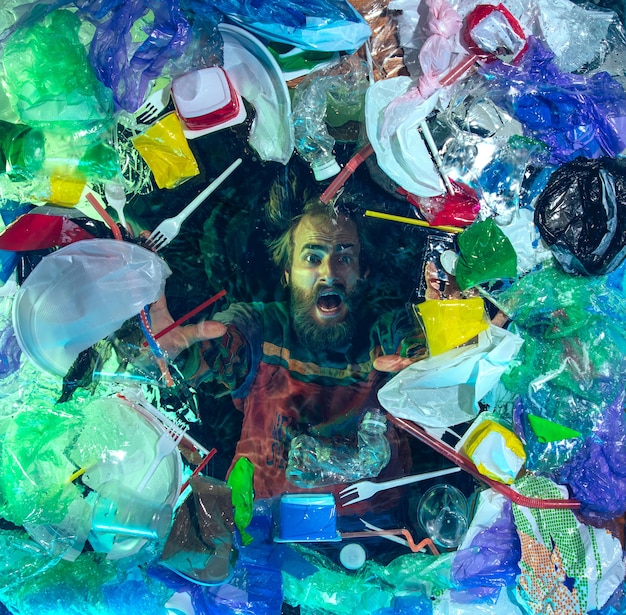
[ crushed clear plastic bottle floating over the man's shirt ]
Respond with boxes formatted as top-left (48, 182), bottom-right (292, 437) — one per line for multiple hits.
top-left (286, 409), bottom-right (391, 488)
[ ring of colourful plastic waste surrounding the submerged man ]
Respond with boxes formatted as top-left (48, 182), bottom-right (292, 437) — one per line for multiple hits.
top-left (0, 0), bottom-right (626, 615)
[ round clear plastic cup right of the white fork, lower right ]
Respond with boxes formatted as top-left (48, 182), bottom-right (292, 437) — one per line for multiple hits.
top-left (417, 484), bottom-right (469, 549)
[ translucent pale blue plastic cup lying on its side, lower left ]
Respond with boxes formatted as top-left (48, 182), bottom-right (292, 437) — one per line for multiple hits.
top-left (92, 480), bottom-right (173, 540)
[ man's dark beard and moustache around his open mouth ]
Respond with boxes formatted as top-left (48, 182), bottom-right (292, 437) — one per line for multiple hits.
top-left (290, 279), bottom-right (365, 353)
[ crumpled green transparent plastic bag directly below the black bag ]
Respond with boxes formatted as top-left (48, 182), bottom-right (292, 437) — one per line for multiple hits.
top-left (496, 266), bottom-right (626, 402)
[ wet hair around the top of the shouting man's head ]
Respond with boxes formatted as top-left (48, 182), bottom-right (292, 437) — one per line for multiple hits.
top-left (268, 198), bottom-right (369, 282)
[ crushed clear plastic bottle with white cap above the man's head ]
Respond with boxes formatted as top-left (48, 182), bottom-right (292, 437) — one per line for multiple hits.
top-left (293, 56), bottom-right (367, 181)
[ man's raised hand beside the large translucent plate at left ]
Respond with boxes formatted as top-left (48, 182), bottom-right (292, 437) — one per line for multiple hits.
top-left (150, 295), bottom-right (226, 359)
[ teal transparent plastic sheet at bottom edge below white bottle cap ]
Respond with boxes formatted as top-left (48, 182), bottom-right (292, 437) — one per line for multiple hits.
top-left (283, 545), bottom-right (454, 615)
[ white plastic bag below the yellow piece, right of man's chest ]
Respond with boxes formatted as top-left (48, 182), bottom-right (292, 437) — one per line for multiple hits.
top-left (378, 325), bottom-right (523, 428)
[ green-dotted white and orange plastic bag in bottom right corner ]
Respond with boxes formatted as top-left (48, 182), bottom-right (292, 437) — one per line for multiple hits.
top-left (513, 475), bottom-right (624, 615)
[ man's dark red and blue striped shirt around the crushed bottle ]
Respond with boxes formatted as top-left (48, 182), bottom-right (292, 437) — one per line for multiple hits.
top-left (190, 303), bottom-right (409, 498)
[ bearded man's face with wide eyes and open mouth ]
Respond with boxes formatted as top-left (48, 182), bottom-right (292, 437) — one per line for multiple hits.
top-left (285, 216), bottom-right (362, 348)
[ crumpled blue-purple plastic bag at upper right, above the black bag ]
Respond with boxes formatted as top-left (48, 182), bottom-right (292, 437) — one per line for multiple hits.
top-left (481, 37), bottom-right (626, 164)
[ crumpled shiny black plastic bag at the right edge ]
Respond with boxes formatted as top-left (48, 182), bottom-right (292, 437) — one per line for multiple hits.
top-left (535, 157), bottom-right (626, 275)
